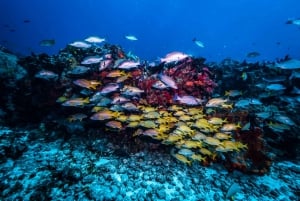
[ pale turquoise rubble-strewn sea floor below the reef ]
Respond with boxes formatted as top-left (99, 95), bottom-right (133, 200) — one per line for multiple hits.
top-left (0, 127), bottom-right (300, 201)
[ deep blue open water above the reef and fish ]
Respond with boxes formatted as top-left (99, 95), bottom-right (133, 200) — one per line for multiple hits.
top-left (0, 0), bottom-right (300, 61)
